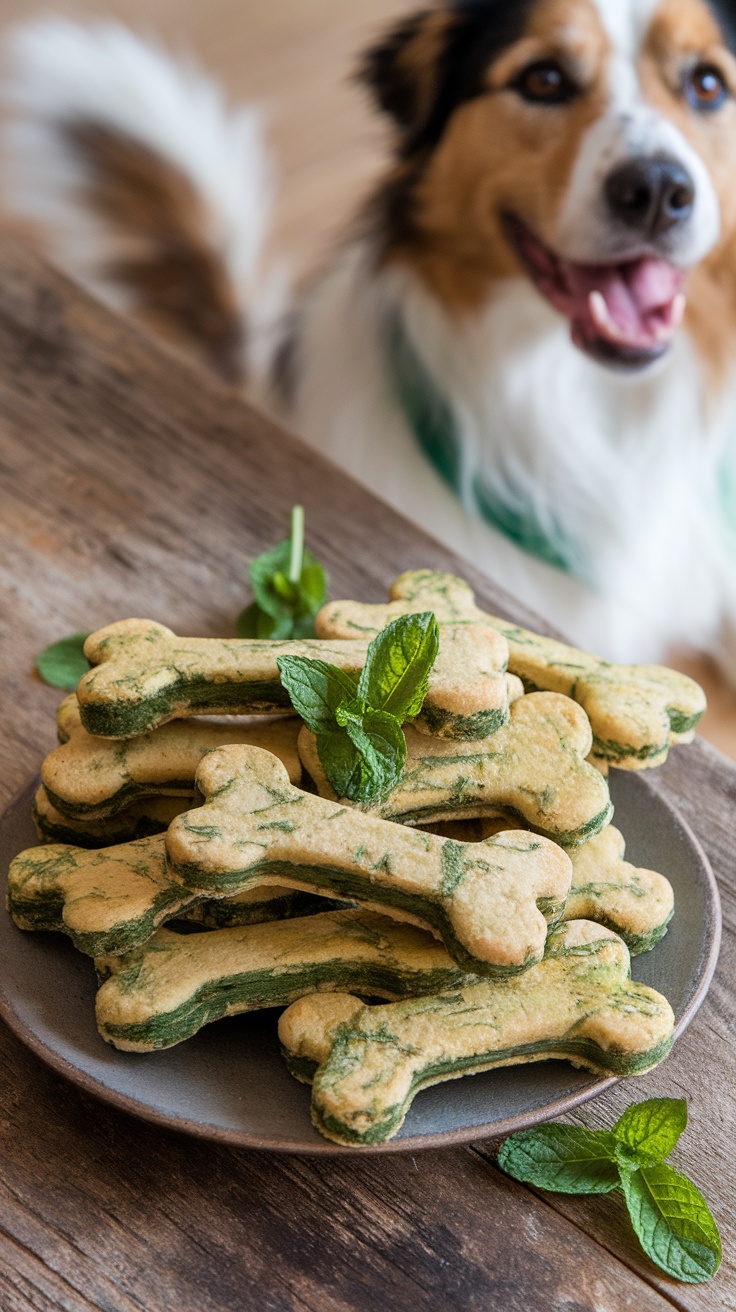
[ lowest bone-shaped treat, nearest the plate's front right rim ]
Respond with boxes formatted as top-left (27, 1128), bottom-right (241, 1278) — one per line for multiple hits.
top-left (278, 921), bottom-right (674, 1144)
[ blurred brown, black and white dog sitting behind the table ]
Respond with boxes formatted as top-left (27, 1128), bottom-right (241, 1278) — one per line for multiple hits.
top-left (7, 0), bottom-right (736, 684)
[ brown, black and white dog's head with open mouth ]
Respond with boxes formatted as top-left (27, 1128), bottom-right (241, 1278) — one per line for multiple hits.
top-left (363, 0), bottom-right (736, 369)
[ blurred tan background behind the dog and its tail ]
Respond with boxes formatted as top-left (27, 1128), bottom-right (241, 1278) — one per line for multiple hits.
top-left (0, 0), bottom-right (736, 757)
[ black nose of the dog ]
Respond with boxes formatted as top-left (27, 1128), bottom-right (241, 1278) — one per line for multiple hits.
top-left (606, 155), bottom-right (695, 237)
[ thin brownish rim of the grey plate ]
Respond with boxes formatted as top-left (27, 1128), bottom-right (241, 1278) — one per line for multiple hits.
top-left (0, 771), bottom-right (723, 1157)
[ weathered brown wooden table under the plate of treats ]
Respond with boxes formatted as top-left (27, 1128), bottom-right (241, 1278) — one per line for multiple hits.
top-left (0, 244), bottom-right (736, 1312)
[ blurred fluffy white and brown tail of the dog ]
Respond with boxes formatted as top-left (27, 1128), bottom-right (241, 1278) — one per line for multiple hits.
top-left (5, 20), bottom-right (272, 380)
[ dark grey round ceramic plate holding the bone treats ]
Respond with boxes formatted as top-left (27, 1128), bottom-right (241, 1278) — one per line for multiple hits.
top-left (0, 771), bottom-right (720, 1153)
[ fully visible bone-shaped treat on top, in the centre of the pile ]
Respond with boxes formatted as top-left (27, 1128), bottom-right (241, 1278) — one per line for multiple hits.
top-left (167, 739), bottom-right (572, 975)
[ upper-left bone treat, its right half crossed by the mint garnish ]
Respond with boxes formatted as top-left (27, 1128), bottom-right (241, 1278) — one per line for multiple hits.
top-left (77, 619), bottom-right (518, 739)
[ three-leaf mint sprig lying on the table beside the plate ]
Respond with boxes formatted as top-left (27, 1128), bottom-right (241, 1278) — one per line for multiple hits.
top-left (499, 1098), bottom-right (722, 1284)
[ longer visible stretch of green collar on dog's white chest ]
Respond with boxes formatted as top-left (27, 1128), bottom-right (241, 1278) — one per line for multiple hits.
top-left (383, 311), bottom-right (589, 583)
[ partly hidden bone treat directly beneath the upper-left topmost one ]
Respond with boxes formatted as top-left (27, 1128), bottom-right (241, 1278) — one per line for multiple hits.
top-left (41, 694), bottom-right (302, 820)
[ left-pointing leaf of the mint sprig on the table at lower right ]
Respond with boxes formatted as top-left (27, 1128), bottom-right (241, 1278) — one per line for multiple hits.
top-left (499, 1124), bottom-right (619, 1194)
